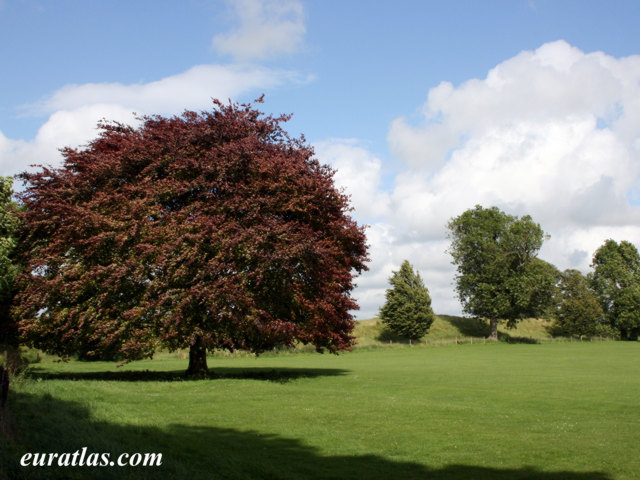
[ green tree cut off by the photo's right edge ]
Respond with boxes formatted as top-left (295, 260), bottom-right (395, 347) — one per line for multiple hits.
top-left (591, 240), bottom-right (640, 340)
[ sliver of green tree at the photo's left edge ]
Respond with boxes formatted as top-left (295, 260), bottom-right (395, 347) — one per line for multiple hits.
top-left (0, 177), bottom-right (19, 347)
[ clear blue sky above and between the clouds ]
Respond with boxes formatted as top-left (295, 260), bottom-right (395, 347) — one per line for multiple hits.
top-left (5, 0), bottom-right (640, 141)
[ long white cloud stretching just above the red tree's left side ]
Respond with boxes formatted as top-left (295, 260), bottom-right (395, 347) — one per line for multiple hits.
top-left (0, 65), bottom-right (305, 175)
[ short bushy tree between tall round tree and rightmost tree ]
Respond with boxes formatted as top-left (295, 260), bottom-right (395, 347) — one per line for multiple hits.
top-left (553, 270), bottom-right (610, 336)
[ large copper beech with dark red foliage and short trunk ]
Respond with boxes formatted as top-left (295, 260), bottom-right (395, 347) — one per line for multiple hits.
top-left (14, 100), bottom-right (368, 374)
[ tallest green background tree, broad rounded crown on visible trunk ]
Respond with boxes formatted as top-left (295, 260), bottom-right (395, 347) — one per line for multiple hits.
top-left (448, 205), bottom-right (557, 339)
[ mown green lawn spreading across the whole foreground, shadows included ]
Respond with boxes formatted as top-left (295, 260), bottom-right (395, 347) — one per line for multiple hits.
top-left (0, 322), bottom-right (640, 480)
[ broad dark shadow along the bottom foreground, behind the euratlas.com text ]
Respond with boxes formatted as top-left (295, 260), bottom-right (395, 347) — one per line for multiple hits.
top-left (0, 393), bottom-right (612, 480)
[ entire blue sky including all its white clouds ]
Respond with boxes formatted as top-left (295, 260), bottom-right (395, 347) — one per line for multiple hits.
top-left (0, 0), bottom-right (640, 317)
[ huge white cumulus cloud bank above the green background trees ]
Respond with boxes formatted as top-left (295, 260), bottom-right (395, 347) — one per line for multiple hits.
top-left (348, 41), bottom-right (640, 318)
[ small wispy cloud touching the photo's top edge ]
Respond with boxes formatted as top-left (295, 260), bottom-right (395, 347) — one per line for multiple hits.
top-left (213, 0), bottom-right (306, 61)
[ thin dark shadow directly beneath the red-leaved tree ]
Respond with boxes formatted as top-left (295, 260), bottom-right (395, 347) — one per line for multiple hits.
top-left (25, 367), bottom-right (348, 383)
